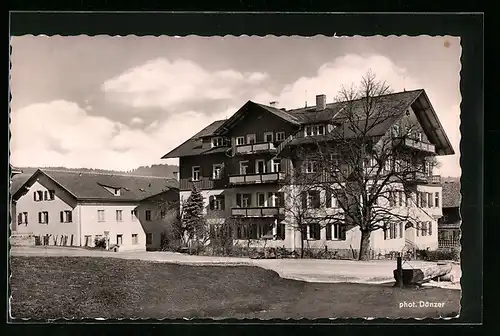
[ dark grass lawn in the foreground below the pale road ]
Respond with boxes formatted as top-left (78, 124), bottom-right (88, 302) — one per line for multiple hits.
top-left (10, 257), bottom-right (460, 319)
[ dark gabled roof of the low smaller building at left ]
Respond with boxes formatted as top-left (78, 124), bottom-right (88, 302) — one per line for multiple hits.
top-left (12, 169), bottom-right (178, 202)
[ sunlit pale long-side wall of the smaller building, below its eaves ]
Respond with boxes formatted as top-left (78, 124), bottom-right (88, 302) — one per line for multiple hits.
top-left (79, 203), bottom-right (146, 251)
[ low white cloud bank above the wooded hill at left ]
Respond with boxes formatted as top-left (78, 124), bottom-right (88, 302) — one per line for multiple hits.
top-left (10, 100), bottom-right (230, 170)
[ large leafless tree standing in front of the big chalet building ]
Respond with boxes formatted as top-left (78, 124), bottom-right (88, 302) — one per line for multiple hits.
top-left (294, 72), bottom-right (436, 260)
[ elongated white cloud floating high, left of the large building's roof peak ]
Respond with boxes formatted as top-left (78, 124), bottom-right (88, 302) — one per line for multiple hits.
top-left (101, 58), bottom-right (268, 110)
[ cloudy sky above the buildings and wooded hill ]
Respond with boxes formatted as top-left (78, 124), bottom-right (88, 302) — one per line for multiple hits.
top-left (10, 35), bottom-right (461, 176)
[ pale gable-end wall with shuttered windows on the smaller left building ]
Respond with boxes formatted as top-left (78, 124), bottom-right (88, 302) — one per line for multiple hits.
top-left (12, 181), bottom-right (80, 246)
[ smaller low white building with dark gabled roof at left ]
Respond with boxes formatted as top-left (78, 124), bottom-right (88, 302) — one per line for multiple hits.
top-left (11, 169), bottom-right (179, 251)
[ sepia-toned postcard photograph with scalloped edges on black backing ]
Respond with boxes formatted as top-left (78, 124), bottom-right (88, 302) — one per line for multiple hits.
top-left (9, 29), bottom-right (464, 321)
